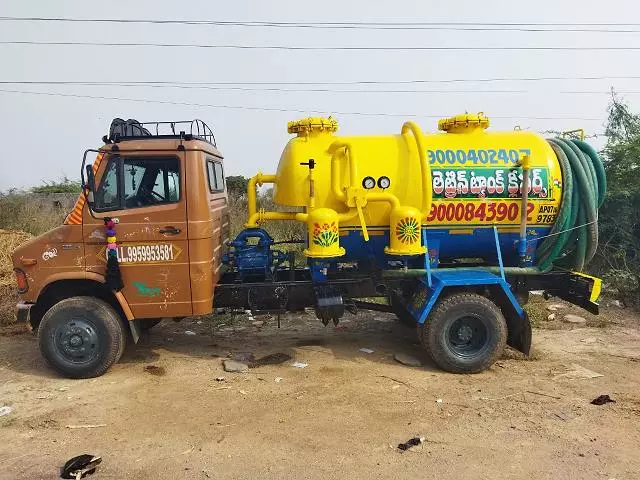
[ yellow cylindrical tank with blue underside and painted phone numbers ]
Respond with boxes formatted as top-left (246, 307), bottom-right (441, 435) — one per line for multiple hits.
top-left (247, 113), bottom-right (562, 263)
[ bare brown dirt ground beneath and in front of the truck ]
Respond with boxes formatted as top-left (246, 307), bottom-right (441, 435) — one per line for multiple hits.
top-left (0, 298), bottom-right (640, 480)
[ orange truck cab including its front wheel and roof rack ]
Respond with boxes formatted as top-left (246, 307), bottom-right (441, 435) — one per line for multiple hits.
top-left (13, 119), bottom-right (229, 377)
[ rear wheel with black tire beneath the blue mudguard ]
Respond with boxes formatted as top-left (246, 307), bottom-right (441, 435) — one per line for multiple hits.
top-left (419, 293), bottom-right (507, 373)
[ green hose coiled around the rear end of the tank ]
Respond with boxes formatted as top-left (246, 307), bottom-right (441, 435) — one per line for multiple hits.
top-left (537, 138), bottom-right (607, 272)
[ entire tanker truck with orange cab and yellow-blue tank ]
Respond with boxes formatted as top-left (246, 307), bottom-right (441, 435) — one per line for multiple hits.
top-left (13, 113), bottom-right (606, 378)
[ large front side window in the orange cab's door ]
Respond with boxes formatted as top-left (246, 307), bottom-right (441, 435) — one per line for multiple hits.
top-left (95, 157), bottom-right (180, 212)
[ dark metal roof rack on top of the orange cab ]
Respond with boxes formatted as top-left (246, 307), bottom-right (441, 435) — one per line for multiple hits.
top-left (102, 118), bottom-right (217, 147)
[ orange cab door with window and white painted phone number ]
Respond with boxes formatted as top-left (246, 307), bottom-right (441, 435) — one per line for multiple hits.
top-left (83, 152), bottom-right (192, 318)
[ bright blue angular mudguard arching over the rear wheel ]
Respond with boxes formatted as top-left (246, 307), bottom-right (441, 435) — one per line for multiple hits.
top-left (407, 269), bottom-right (524, 325)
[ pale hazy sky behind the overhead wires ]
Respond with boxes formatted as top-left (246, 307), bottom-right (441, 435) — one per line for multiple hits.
top-left (0, 0), bottom-right (640, 191)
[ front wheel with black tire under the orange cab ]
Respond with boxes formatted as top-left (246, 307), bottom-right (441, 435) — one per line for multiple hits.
top-left (38, 297), bottom-right (126, 378)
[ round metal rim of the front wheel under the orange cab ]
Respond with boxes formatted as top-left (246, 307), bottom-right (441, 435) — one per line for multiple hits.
top-left (54, 318), bottom-right (99, 364)
